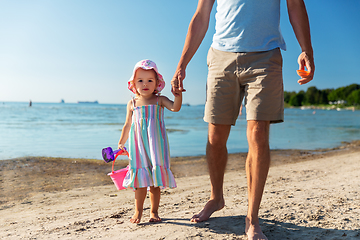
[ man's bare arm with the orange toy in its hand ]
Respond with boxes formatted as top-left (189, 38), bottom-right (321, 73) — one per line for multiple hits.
top-left (287, 0), bottom-right (315, 85)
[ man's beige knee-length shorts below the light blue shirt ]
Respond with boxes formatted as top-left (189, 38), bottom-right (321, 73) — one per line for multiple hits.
top-left (204, 48), bottom-right (284, 125)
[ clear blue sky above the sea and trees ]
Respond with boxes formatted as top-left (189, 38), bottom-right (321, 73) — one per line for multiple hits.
top-left (0, 0), bottom-right (360, 104)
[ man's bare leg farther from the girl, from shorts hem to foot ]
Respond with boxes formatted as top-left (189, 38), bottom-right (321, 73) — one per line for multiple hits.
top-left (245, 121), bottom-right (270, 240)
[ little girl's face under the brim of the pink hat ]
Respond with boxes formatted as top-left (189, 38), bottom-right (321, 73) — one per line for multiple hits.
top-left (134, 68), bottom-right (157, 96)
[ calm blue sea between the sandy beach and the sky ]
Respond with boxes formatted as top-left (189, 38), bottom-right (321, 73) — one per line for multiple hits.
top-left (0, 102), bottom-right (360, 160)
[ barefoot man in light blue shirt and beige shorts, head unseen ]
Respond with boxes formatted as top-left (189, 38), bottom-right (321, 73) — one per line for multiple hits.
top-left (171, 0), bottom-right (315, 239)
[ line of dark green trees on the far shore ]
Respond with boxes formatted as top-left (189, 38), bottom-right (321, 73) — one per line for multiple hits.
top-left (284, 84), bottom-right (360, 107)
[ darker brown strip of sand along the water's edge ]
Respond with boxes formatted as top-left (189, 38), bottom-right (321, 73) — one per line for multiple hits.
top-left (0, 140), bottom-right (360, 204)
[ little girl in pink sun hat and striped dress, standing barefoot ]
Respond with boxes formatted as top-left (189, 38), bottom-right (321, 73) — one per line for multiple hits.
top-left (118, 60), bottom-right (182, 223)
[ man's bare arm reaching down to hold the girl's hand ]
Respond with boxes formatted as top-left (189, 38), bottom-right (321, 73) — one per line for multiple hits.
top-left (171, 0), bottom-right (215, 92)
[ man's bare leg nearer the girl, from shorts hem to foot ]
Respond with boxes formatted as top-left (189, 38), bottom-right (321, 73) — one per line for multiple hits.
top-left (190, 123), bottom-right (231, 222)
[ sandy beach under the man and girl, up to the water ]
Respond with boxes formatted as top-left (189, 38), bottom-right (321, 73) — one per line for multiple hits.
top-left (0, 141), bottom-right (360, 240)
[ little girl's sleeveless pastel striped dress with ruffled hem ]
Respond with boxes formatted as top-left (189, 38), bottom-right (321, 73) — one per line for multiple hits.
top-left (123, 101), bottom-right (176, 189)
